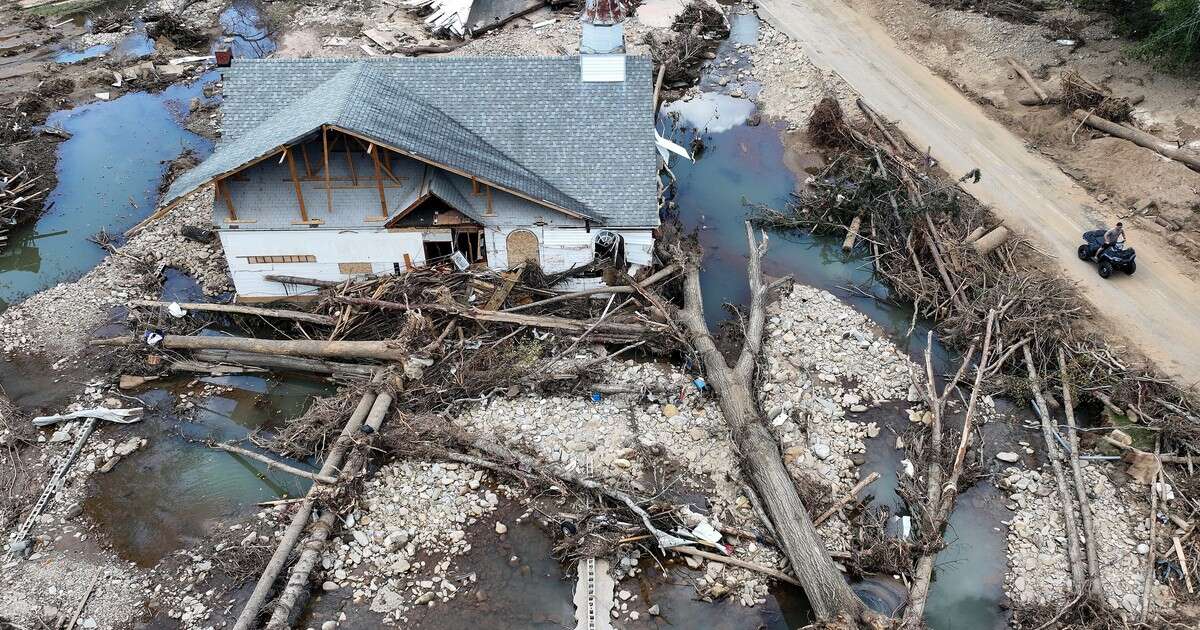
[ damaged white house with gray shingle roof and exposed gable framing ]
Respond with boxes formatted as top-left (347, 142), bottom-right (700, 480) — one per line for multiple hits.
top-left (163, 4), bottom-right (659, 301)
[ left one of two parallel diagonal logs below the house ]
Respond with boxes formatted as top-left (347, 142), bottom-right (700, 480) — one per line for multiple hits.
top-left (234, 377), bottom-right (391, 630)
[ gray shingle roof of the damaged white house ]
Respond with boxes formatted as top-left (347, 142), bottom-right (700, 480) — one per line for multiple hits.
top-left (163, 56), bottom-right (658, 227)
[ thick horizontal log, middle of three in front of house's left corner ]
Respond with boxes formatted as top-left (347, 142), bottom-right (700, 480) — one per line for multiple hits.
top-left (89, 335), bottom-right (407, 361)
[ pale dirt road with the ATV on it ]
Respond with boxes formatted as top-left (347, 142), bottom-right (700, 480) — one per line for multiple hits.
top-left (757, 0), bottom-right (1200, 388)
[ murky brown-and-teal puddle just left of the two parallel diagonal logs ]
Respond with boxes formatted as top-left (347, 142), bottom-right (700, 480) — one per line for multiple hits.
top-left (84, 376), bottom-right (332, 566)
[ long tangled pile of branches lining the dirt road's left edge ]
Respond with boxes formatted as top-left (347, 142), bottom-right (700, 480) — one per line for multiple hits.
top-left (755, 97), bottom-right (1200, 452)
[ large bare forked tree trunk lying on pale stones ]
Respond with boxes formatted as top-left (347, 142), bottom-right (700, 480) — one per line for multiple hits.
top-left (679, 222), bottom-right (866, 623)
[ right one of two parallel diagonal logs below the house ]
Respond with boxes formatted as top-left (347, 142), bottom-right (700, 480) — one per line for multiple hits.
top-left (266, 394), bottom-right (391, 630)
